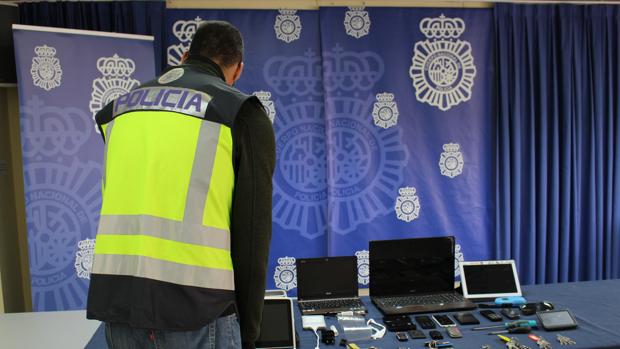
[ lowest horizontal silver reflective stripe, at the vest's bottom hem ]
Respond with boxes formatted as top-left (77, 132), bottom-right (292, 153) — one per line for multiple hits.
top-left (93, 254), bottom-right (235, 291)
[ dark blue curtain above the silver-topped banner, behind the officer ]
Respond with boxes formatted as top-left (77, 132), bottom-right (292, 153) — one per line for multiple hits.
top-left (19, 1), bottom-right (166, 72)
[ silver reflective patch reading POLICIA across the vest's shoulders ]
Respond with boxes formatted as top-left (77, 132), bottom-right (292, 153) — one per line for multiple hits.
top-left (113, 86), bottom-right (211, 118)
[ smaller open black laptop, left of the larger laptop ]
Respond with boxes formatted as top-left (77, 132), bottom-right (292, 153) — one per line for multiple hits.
top-left (297, 256), bottom-right (366, 315)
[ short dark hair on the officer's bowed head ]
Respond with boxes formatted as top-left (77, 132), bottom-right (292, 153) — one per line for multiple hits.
top-left (189, 21), bottom-right (243, 67)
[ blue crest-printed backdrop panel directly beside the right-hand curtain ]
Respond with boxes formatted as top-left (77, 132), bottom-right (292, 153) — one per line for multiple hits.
top-left (320, 7), bottom-right (495, 285)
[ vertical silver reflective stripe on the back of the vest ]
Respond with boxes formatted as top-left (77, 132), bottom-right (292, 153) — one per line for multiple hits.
top-left (183, 121), bottom-right (221, 224)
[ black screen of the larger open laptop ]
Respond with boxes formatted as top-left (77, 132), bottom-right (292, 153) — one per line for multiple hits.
top-left (370, 236), bottom-right (454, 297)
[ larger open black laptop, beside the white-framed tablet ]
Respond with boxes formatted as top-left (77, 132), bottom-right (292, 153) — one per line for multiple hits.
top-left (370, 236), bottom-right (476, 315)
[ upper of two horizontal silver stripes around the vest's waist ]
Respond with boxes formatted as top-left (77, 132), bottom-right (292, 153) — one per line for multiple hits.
top-left (97, 215), bottom-right (230, 251)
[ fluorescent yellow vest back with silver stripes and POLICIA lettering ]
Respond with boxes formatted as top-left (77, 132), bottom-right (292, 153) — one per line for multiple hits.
top-left (92, 85), bottom-right (235, 290)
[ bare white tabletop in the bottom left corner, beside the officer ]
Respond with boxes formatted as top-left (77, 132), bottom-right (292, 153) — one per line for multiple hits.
top-left (0, 310), bottom-right (101, 349)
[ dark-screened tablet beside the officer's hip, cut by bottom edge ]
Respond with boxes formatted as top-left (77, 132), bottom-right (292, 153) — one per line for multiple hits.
top-left (256, 298), bottom-right (295, 349)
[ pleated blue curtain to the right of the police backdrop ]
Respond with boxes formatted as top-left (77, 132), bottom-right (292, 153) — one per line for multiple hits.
top-left (494, 4), bottom-right (620, 284)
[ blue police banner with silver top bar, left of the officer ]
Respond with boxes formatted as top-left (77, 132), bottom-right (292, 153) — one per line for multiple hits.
top-left (13, 25), bottom-right (155, 311)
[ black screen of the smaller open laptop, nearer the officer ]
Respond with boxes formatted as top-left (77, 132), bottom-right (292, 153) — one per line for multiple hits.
top-left (297, 256), bottom-right (357, 300)
